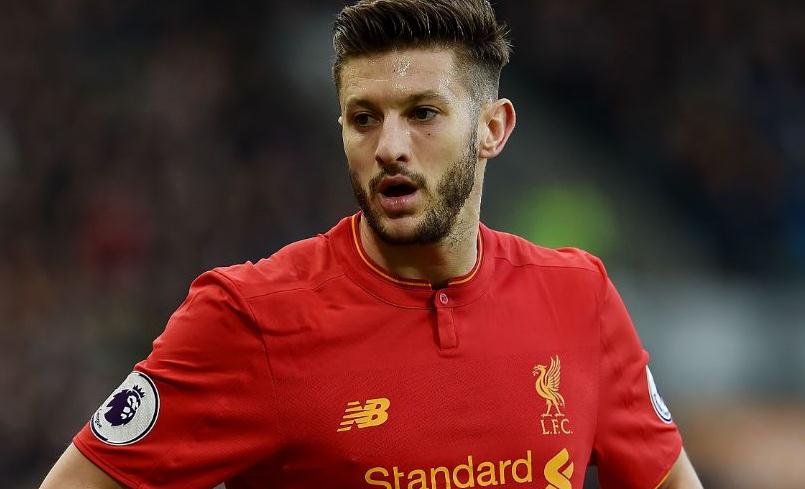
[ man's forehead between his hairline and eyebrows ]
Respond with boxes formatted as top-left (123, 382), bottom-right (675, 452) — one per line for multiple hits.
top-left (339, 48), bottom-right (467, 105)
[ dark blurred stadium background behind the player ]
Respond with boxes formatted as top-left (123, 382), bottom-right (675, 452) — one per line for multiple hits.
top-left (0, 0), bottom-right (805, 488)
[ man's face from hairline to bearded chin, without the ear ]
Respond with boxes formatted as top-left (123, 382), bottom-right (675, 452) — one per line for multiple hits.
top-left (339, 49), bottom-right (478, 244)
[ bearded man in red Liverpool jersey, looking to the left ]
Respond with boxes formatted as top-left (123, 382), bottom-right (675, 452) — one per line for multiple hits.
top-left (43, 0), bottom-right (700, 489)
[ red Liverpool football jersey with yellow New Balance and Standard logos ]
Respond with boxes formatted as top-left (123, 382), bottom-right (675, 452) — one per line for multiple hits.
top-left (73, 214), bottom-right (681, 489)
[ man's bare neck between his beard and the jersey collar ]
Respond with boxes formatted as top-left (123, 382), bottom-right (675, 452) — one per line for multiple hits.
top-left (359, 177), bottom-right (481, 289)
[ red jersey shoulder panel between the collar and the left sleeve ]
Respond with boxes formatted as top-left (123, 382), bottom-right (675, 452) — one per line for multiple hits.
top-left (205, 234), bottom-right (343, 300)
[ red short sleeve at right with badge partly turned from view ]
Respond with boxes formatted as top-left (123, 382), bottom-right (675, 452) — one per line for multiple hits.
top-left (593, 279), bottom-right (682, 489)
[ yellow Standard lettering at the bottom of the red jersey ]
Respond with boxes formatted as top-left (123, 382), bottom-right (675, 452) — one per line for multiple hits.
top-left (364, 450), bottom-right (533, 489)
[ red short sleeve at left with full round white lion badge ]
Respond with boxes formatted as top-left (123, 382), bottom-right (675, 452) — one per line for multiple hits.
top-left (73, 271), bottom-right (279, 488)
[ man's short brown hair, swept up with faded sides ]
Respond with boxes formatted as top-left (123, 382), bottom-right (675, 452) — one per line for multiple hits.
top-left (333, 0), bottom-right (511, 100)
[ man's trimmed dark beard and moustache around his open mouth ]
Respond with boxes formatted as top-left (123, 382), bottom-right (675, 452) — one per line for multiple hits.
top-left (350, 127), bottom-right (478, 245)
